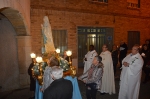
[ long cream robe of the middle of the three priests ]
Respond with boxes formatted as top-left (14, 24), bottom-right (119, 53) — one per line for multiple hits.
top-left (100, 51), bottom-right (116, 94)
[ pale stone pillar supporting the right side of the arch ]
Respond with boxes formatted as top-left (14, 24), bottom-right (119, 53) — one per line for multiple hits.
top-left (16, 36), bottom-right (31, 87)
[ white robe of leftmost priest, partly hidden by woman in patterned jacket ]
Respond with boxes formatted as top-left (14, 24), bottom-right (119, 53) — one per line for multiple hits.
top-left (83, 50), bottom-right (97, 73)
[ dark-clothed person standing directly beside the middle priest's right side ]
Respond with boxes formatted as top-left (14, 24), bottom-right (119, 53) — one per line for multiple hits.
top-left (111, 45), bottom-right (118, 75)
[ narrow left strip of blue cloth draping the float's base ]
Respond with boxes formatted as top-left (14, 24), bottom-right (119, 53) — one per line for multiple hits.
top-left (35, 80), bottom-right (43, 99)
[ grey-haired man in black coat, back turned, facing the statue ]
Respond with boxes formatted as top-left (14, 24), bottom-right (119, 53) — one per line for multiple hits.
top-left (43, 66), bottom-right (73, 99)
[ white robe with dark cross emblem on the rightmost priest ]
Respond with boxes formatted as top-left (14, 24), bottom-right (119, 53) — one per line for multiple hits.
top-left (118, 53), bottom-right (143, 99)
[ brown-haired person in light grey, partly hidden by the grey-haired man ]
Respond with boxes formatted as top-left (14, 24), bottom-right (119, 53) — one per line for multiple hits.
top-left (41, 56), bottom-right (59, 91)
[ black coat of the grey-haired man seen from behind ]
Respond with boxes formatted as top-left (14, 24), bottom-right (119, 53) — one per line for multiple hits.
top-left (43, 78), bottom-right (73, 99)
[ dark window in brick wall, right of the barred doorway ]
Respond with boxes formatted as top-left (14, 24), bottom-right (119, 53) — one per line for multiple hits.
top-left (128, 31), bottom-right (140, 50)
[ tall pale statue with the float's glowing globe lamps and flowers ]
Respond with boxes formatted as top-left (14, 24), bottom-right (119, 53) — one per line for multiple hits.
top-left (30, 16), bottom-right (76, 85)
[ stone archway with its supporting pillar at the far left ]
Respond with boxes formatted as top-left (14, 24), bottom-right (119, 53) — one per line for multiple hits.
top-left (0, 8), bottom-right (31, 91)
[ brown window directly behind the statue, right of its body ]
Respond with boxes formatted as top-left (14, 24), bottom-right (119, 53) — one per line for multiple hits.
top-left (52, 30), bottom-right (67, 55)
